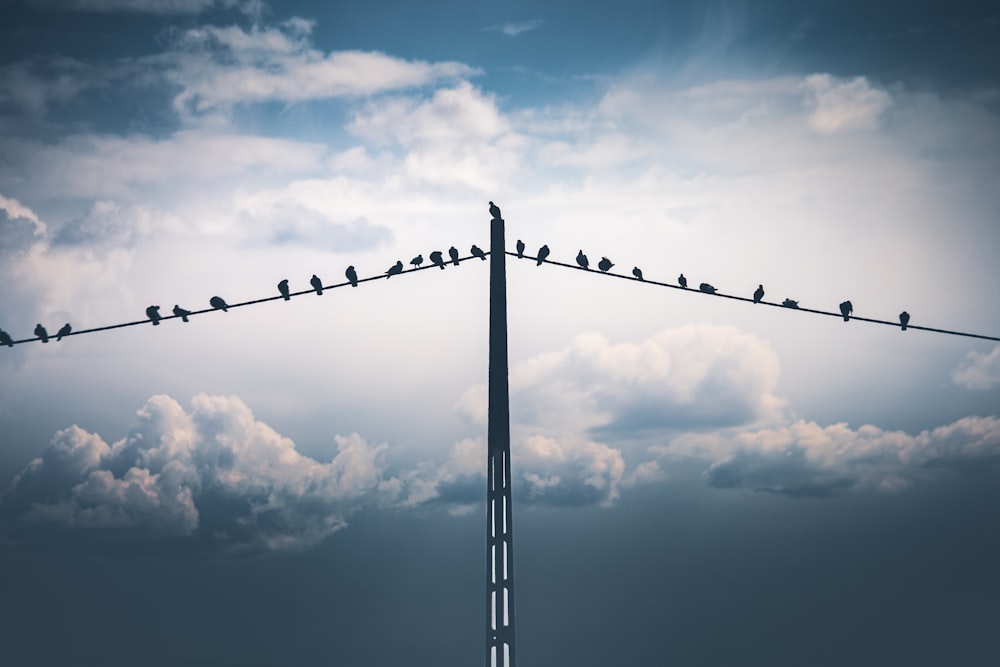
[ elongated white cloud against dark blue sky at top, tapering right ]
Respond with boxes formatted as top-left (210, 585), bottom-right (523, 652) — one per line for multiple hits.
top-left (162, 18), bottom-right (476, 116)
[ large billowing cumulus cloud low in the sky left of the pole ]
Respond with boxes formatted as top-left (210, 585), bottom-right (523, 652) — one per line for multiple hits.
top-left (3, 395), bottom-right (392, 550)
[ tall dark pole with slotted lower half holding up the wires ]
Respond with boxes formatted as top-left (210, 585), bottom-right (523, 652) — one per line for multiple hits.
top-left (486, 211), bottom-right (517, 667)
